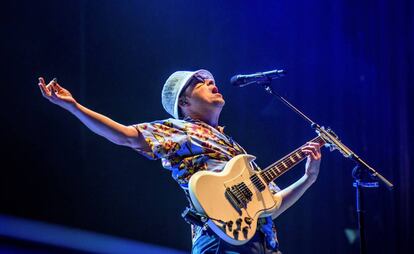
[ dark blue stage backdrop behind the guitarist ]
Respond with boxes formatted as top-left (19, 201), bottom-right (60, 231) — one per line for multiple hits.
top-left (0, 0), bottom-right (414, 253)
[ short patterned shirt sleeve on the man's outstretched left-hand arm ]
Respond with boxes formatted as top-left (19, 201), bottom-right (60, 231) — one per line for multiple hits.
top-left (133, 119), bottom-right (188, 160)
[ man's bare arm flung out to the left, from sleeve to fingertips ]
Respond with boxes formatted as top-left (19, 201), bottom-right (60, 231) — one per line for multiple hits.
top-left (38, 77), bottom-right (149, 151)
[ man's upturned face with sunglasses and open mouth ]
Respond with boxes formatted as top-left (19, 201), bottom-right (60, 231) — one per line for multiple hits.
top-left (182, 75), bottom-right (225, 111)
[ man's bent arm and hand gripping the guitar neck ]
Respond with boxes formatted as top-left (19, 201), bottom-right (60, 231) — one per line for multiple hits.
top-left (272, 142), bottom-right (321, 219)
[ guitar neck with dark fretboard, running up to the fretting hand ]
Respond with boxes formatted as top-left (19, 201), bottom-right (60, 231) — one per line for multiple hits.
top-left (260, 136), bottom-right (325, 184)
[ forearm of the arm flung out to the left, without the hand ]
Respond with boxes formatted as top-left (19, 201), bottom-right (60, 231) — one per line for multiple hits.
top-left (69, 103), bottom-right (138, 146)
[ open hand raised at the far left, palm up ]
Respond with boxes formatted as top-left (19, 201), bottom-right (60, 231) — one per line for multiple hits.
top-left (38, 77), bottom-right (76, 110)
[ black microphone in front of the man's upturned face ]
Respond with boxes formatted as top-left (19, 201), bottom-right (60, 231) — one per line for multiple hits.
top-left (230, 70), bottom-right (286, 87)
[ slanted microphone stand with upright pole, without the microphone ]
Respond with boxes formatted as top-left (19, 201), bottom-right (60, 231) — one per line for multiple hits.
top-left (257, 78), bottom-right (394, 254)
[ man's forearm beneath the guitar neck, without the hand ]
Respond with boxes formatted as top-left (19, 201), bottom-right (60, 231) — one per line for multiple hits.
top-left (272, 174), bottom-right (316, 219)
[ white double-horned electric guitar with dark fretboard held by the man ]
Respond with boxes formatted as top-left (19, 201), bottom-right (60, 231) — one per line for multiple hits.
top-left (189, 136), bottom-right (325, 245)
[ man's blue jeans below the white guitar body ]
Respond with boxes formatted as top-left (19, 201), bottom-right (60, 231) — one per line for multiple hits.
top-left (191, 228), bottom-right (282, 254)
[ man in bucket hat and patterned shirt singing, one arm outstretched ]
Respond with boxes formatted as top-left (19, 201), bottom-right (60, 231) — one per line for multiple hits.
top-left (39, 70), bottom-right (321, 253)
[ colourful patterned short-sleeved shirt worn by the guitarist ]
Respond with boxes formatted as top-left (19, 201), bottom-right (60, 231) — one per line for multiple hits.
top-left (134, 117), bottom-right (279, 248)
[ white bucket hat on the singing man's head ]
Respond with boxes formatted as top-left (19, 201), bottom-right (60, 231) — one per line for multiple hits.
top-left (161, 70), bottom-right (214, 119)
